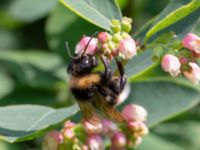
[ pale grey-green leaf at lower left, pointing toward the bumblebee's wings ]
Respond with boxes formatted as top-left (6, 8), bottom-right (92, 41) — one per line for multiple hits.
top-left (0, 105), bottom-right (78, 142)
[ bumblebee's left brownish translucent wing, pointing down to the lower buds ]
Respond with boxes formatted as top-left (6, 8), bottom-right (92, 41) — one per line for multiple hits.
top-left (78, 102), bottom-right (101, 125)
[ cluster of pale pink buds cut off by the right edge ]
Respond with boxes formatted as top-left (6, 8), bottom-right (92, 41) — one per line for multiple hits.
top-left (161, 33), bottom-right (200, 84)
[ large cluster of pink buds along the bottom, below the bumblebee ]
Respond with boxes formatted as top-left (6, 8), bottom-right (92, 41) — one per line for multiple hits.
top-left (42, 104), bottom-right (148, 150)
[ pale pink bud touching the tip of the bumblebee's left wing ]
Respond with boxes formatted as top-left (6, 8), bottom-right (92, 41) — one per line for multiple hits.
top-left (83, 121), bottom-right (103, 134)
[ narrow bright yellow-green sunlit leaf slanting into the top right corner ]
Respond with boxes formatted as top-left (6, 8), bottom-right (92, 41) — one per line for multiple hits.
top-left (145, 0), bottom-right (200, 41)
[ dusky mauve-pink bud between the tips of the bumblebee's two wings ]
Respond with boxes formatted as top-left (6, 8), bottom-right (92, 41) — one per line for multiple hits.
top-left (102, 119), bottom-right (118, 137)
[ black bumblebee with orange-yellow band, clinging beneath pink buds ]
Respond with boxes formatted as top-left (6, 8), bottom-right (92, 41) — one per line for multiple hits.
top-left (67, 39), bottom-right (127, 122)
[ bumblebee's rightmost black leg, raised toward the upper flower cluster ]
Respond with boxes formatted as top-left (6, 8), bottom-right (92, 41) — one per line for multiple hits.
top-left (115, 59), bottom-right (127, 93)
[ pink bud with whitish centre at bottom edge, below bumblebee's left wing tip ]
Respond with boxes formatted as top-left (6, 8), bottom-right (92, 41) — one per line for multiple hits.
top-left (86, 135), bottom-right (104, 150)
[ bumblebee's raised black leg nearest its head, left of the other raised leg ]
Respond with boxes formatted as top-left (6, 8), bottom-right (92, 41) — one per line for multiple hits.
top-left (101, 55), bottom-right (112, 85)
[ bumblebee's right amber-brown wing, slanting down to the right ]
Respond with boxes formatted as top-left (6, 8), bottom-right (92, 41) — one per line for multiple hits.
top-left (94, 93), bottom-right (125, 122)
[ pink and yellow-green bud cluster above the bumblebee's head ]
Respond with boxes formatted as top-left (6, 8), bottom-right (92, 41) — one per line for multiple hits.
top-left (75, 17), bottom-right (137, 59)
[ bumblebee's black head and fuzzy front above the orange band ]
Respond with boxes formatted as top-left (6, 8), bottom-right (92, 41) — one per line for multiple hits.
top-left (67, 54), bottom-right (98, 76)
